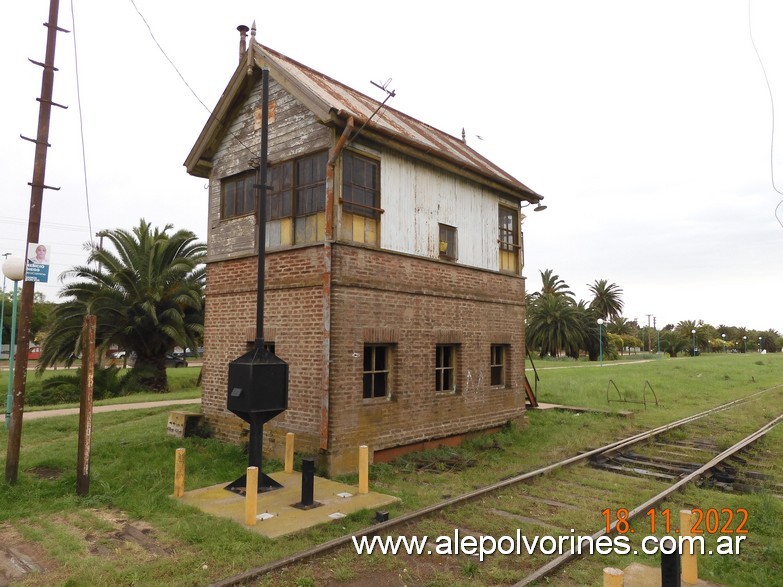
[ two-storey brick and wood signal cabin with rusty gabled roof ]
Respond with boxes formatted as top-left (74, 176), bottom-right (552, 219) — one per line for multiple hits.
top-left (185, 31), bottom-right (542, 474)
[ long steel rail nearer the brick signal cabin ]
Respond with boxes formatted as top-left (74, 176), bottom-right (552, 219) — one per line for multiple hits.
top-left (207, 384), bottom-right (783, 587)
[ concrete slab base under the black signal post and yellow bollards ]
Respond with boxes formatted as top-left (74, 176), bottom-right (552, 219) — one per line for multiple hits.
top-left (179, 472), bottom-right (400, 538)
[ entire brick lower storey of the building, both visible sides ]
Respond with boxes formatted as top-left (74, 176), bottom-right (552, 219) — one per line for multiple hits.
top-left (202, 244), bottom-right (525, 474)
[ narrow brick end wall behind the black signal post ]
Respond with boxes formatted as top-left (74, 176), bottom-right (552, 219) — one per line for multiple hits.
top-left (202, 246), bottom-right (323, 455)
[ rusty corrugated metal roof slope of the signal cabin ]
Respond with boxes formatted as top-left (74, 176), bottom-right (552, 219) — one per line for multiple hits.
top-left (251, 40), bottom-right (542, 201)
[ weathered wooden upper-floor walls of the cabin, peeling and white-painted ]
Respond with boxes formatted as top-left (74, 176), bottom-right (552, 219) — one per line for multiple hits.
top-left (208, 71), bottom-right (521, 274)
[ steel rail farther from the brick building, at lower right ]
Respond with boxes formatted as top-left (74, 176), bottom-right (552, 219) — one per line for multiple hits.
top-left (513, 414), bottom-right (783, 587)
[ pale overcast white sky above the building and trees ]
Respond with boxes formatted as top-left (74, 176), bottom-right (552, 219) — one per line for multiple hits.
top-left (0, 0), bottom-right (783, 332)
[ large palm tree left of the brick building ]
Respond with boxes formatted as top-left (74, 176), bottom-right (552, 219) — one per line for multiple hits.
top-left (39, 219), bottom-right (206, 391)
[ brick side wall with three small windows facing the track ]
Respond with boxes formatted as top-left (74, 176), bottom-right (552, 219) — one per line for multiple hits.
top-left (329, 245), bottom-right (525, 472)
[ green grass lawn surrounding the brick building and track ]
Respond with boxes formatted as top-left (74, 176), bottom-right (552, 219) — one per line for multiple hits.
top-left (0, 354), bottom-right (783, 587)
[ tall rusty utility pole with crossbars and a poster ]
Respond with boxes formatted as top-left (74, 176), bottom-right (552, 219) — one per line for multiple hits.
top-left (5, 0), bottom-right (69, 484)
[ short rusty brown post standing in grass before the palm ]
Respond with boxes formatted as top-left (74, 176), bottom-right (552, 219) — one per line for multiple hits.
top-left (76, 314), bottom-right (96, 497)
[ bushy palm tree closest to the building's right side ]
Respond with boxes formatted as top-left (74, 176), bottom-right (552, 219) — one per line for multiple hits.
top-left (526, 293), bottom-right (584, 358)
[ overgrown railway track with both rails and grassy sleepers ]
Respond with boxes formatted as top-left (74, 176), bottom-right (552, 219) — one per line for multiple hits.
top-left (212, 388), bottom-right (783, 587)
